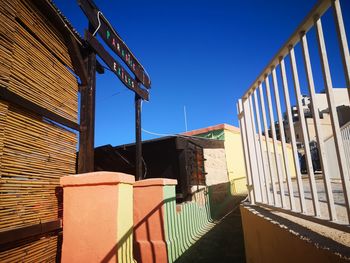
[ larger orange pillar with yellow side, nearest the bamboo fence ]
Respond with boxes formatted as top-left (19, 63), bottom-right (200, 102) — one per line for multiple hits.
top-left (60, 172), bottom-right (135, 263)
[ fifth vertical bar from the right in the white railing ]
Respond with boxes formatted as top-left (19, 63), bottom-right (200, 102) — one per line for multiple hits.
top-left (280, 58), bottom-right (306, 214)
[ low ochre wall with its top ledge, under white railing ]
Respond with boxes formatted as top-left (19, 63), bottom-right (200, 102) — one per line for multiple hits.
top-left (240, 205), bottom-right (349, 263)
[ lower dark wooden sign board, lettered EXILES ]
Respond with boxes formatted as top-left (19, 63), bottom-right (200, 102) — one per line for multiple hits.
top-left (85, 31), bottom-right (149, 100)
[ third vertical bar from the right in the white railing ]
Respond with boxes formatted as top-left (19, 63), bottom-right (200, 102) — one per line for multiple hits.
top-left (301, 32), bottom-right (333, 220)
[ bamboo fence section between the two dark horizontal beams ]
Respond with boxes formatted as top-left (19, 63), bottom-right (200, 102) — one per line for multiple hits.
top-left (0, 103), bottom-right (77, 231)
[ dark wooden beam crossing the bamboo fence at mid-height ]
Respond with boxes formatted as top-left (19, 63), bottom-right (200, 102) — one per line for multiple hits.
top-left (0, 87), bottom-right (80, 131)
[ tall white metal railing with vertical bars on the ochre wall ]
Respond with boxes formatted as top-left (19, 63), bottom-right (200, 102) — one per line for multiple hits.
top-left (237, 0), bottom-right (350, 225)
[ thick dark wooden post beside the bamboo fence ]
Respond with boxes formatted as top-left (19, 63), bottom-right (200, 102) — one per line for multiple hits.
top-left (78, 24), bottom-right (96, 173)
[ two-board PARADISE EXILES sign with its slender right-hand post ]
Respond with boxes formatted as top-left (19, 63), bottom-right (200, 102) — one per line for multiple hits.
top-left (78, 0), bottom-right (151, 180)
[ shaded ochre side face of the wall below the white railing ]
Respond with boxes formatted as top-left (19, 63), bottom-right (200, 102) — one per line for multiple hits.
top-left (241, 205), bottom-right (345, 263)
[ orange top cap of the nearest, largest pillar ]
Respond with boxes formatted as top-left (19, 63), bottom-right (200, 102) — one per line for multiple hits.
top-left (60, 172), bottom-right (135, 187)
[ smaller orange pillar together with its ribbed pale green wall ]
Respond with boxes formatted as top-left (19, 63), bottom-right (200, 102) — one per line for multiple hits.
top-left (134, 179), bottom-right (212, 262)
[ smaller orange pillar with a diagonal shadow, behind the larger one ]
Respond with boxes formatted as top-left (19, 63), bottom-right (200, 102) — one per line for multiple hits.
top-left (134, 179), bottom-right (177, 263)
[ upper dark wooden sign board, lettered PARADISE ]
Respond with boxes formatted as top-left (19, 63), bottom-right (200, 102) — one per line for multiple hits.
top-left (78, 0), bottom-right (151, 88)
